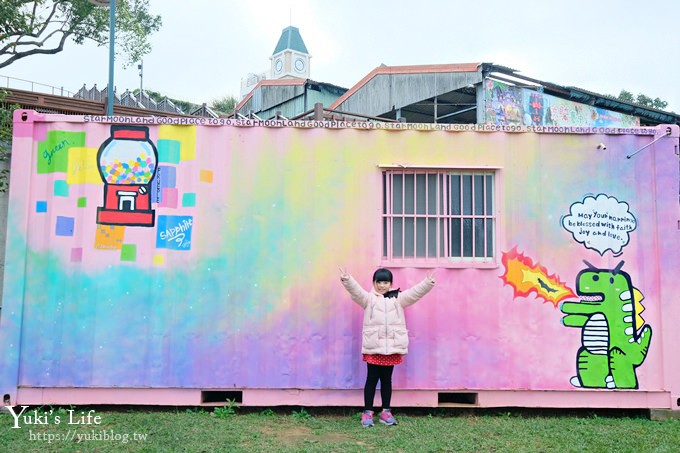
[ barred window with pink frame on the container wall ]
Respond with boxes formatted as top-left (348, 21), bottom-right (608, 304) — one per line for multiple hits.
top-left (382, 170), bottom-right (497, 266)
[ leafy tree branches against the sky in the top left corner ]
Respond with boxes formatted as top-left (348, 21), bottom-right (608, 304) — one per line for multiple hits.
top-left (0, 0), bottom-right (161, 68)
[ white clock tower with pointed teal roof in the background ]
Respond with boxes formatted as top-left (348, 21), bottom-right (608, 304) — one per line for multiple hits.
top-left (269, 26), bottom-right (312, 79)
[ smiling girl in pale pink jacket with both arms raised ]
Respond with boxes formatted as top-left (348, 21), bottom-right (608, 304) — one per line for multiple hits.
top-left (340, 268), bottom-right (435, 428)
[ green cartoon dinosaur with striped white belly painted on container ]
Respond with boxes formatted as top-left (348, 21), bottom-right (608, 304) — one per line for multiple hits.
top-left (560, 260), bottom-right (652, 389)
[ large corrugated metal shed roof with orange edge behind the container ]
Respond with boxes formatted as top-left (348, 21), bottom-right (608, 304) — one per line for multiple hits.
top-left (329, 63), bottom-right (680, 125)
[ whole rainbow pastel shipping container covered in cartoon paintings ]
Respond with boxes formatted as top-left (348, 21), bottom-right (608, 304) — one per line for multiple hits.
top-left (0, 111), bottom-right (680, 410)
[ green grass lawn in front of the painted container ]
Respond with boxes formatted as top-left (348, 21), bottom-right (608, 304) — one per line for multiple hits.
top-left (0, 405), bottom-right (680, 453)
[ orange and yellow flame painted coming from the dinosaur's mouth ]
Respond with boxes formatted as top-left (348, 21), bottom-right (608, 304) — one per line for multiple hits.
top-left (500, 247), bottom-right (577, 308)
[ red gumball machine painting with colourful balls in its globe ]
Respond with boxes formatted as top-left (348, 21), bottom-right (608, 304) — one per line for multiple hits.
top-left (97, 126), bottom-right (158, 227)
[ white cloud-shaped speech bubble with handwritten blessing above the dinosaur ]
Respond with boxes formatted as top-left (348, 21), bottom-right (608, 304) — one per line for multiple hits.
top-left (561, 193), bottom-right (637, 256)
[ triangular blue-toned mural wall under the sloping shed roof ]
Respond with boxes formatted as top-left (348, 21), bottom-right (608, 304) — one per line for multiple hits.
top-left (484, 79), bottom-right (640, 127)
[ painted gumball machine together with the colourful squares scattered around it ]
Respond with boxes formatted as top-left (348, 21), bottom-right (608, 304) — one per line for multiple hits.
top-left (35, 125), bottom-right (198, 265)
